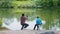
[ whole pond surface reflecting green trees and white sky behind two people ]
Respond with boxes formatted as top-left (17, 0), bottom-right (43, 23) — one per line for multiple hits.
top-left (0, 8), bottom-right (60, 30)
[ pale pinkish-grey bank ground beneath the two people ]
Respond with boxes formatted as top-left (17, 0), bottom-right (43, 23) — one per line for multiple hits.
top-left (0, 30), bottom-right (60, 34)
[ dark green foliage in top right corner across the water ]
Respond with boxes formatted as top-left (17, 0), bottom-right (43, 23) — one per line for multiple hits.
top-left (36, 0), bottom-right (60, 8)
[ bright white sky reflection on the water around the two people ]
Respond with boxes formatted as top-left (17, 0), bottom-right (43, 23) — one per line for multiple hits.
top-left (2, 18), bottom-right (45, 30)
